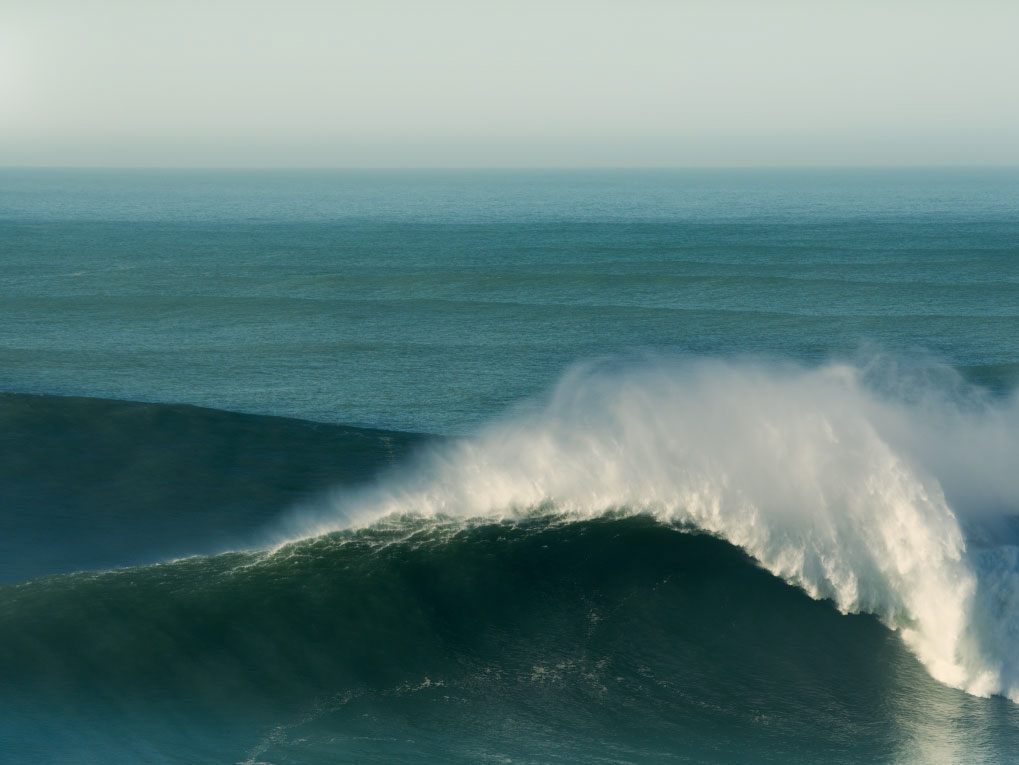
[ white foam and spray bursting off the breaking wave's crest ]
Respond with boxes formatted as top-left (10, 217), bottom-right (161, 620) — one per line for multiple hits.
top-left (287, 361), bottom-right (1019, 701)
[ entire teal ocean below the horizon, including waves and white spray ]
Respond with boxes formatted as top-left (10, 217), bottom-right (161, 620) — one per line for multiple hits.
top-left (0, 168), bottom-right (1019, 765)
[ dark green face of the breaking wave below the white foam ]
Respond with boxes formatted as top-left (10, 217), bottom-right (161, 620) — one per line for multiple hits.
top-left (0, 514), bottom-right (1019, 763)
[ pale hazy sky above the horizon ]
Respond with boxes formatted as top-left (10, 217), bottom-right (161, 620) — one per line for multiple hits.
top-left (0, 0), bottom-right (1019, 167)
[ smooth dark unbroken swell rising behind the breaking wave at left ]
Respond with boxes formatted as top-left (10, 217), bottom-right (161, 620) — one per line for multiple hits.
top-left (0, 393), bottom-right (422, 583)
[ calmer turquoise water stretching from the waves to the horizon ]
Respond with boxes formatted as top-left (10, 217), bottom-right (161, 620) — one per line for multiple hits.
top-left (0, 170), bottom-right (1019, 433)
